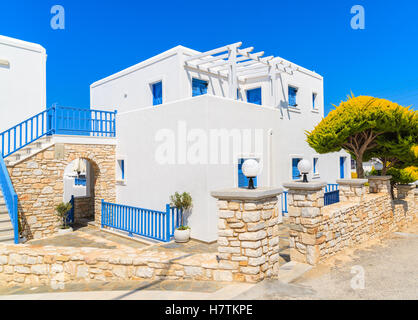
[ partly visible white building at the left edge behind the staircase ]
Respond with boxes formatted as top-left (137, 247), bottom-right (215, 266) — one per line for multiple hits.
top-left (0, 35), bottom-right (47, 132)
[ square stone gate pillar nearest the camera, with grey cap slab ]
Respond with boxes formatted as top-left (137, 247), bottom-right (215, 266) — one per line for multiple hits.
top-left (212, 189), bottom-right (282, 282)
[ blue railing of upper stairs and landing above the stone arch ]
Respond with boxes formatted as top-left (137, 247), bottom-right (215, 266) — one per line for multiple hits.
top-left (0, 107), bottom-right (116, 158)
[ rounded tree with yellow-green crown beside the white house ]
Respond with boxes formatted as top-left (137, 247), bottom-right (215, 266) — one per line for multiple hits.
top-left (306, 95), bottom-right (418, 178)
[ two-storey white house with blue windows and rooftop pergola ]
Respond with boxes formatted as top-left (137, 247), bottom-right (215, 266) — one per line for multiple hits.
top-left (90, 43), bottom-right (351, 241)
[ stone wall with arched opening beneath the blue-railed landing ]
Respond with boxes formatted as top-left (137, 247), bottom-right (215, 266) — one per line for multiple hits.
top-left (8, 144), bottom-right (116, 239)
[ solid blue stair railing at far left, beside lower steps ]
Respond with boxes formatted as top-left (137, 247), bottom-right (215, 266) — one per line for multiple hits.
top-left (0, 157), bottom-right (19, 244)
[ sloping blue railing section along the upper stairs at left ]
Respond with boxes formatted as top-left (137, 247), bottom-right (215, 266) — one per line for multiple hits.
top-left (0, 110), bottom-right (50, 158)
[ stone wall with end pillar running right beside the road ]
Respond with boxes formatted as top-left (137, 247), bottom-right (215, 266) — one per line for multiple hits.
top-left (288, 179), bottom-right (418, 265)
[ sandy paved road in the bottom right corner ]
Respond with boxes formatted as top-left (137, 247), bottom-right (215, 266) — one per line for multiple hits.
top-left (237, 224), bottom-right (418, 299)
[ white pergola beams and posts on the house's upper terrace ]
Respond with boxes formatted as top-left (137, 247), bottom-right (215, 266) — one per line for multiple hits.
top-left (184, 42), bottom-right (299, 99)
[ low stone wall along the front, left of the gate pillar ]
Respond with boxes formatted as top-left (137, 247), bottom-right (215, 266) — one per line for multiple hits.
top-left (0, 244), bottom-right (219, 289)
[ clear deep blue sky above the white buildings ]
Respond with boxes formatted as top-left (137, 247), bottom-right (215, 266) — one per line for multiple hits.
top-left (0, 0), bottom-right (418, 112)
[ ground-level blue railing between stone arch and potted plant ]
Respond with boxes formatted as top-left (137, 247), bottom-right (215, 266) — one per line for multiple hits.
top-left (101, 200), bottom-right (181, 242)
